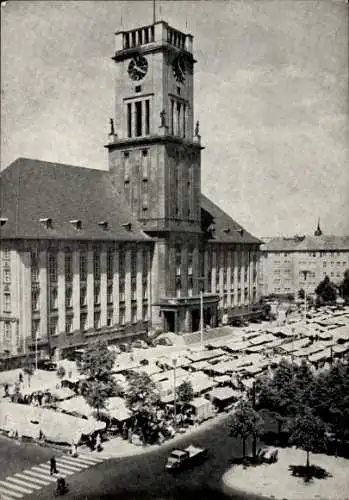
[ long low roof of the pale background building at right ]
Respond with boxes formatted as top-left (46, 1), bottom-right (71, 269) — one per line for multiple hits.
top-left (261, 235), bottom-right (349, 252)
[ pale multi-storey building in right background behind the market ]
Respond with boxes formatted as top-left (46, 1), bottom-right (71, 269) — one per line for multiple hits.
top-left (259, 224), bottom-right (349, 296)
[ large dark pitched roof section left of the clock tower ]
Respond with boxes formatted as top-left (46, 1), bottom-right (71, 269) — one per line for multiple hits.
top-left (0, 158), bottom-right (151, 241)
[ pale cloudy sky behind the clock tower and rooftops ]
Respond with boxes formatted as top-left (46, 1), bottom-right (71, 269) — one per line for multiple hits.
top-left (1, 0), bottom-right (349, 237)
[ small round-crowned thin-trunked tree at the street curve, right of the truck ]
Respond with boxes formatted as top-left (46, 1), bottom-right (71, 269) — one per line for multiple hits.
top-left (230, 400), bottom-right (263, 458)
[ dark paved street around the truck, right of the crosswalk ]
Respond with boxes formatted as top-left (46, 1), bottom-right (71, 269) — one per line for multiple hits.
top-left (23, 419), bottom-right (253, 500)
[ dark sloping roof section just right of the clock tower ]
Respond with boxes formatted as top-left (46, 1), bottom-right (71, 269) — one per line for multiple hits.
top-left (201, 194), bottom-right (262, 244)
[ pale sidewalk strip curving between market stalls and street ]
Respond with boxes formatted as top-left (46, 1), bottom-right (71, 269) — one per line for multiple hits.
top-left (85, 413), bottom-right (229, 459)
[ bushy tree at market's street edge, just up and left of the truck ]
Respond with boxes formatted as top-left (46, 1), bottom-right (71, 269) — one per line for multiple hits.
top-left (125, 372), bottom-right (160, 443)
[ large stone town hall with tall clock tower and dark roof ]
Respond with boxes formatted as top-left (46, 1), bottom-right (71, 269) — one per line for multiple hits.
top-left (0, 21), bottom-right (260, 354)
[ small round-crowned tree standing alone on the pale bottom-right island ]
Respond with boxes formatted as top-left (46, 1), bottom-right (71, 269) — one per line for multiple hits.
top-left (289, 407), bottom-right (326, 469)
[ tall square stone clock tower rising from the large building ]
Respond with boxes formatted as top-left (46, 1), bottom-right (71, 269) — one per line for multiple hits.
top-left (106, 21), bottom-right (208, 331)
